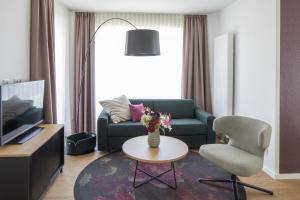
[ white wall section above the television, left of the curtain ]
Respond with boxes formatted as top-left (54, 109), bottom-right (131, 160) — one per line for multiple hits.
top-left (0, 0), bottom-right (30, 81)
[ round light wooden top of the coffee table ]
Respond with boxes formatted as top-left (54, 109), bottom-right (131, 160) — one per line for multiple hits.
top-left (122, 136), bottom-right (189, 163)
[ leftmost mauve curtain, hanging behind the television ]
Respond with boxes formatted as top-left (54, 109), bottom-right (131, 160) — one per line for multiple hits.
top-left (30, 0), bottom-right (56, 124)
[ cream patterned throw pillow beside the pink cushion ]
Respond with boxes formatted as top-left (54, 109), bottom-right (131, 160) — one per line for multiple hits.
top-left (99, 95), bottom-right (131, 123)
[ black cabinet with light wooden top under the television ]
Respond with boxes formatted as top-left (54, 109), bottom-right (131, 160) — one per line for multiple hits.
top-left (0, 124), bottom-right (64, 200)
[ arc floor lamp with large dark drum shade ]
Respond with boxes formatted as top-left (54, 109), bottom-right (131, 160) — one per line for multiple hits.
top-left (75, 17), bottom-right (160, 131)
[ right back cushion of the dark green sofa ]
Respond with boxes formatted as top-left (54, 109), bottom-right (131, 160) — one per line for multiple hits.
top-left (153, 99), bottom-right (194, 119)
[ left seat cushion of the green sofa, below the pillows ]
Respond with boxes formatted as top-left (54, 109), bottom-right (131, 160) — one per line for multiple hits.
top-left (107, 121), bottom-right (148, 137)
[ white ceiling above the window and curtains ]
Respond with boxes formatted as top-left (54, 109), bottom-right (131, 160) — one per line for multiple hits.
top-left (57, 0), bottom-right (236, 14)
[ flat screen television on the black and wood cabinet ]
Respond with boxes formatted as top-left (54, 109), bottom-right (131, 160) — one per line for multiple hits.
top-left (0, 80), bottom-right (44, 145)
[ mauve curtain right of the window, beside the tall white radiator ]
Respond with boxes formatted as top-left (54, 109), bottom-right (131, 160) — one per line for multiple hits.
top-left (181, 15), bottom-right (212, 112)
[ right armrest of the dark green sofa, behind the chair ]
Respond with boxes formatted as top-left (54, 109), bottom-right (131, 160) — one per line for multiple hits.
top-left (195, 107), bottom-right (216, 144)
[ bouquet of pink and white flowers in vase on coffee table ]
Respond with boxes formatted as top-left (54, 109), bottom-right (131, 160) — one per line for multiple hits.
top-left (141, 107), bottom-right (172, 148)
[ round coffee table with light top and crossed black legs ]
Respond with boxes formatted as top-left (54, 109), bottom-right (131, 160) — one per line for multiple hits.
top-left (122, 136), bottom-right (189, 189)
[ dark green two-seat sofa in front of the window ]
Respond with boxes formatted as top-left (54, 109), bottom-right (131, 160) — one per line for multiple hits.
top-left (97, 99), bottom-right (216, 151)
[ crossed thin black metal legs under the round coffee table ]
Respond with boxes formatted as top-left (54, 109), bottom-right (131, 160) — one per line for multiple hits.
top-left (133, 161), bottom-right (177, 190)
